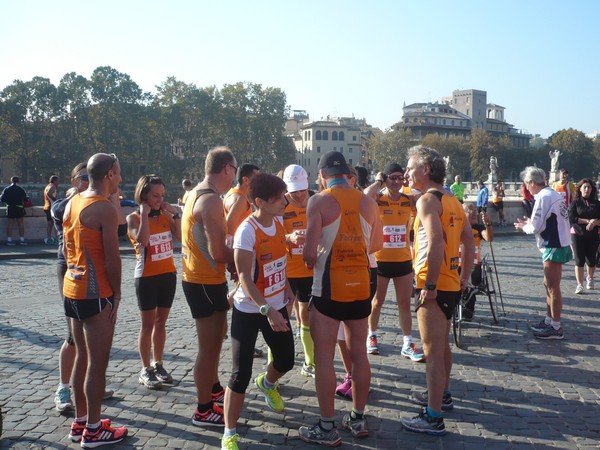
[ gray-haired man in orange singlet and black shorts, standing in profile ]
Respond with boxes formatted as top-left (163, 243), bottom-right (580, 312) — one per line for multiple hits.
top-left (400, 146), bottom-right (475, 435)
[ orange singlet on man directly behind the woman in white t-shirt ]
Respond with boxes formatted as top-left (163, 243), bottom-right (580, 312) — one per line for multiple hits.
top-left (181, 189), bottom-right (227, 284)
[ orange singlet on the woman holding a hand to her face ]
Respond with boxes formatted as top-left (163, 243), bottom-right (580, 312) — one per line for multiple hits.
top-left (128, 211), bottom-right (177, 278)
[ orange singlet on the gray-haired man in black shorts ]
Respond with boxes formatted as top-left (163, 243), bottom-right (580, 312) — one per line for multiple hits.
top-left (414, 189), bottom-right (467, 292)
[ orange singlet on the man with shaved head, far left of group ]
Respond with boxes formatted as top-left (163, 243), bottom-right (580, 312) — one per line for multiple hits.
top-left (63, 194), bottom-right (117, 300)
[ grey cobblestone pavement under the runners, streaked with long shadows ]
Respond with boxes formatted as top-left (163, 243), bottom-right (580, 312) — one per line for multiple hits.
top-left (0, 236), bottom-right (600, 450)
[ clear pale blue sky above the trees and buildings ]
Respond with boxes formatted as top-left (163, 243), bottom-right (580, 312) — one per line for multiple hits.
top-left (0, 0), bottom-right (600, 137)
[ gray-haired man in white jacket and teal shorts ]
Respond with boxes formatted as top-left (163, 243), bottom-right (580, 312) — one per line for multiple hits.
top-left (515, 166), bottom-right (573, 339)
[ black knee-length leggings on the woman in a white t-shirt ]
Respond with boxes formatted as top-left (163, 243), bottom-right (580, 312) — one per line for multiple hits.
top-left (228, 307), bottom-right (295, 394)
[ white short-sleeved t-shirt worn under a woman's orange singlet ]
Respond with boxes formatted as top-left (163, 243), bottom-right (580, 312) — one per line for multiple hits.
top-left (233, 216), bottom-right (287, 313)
